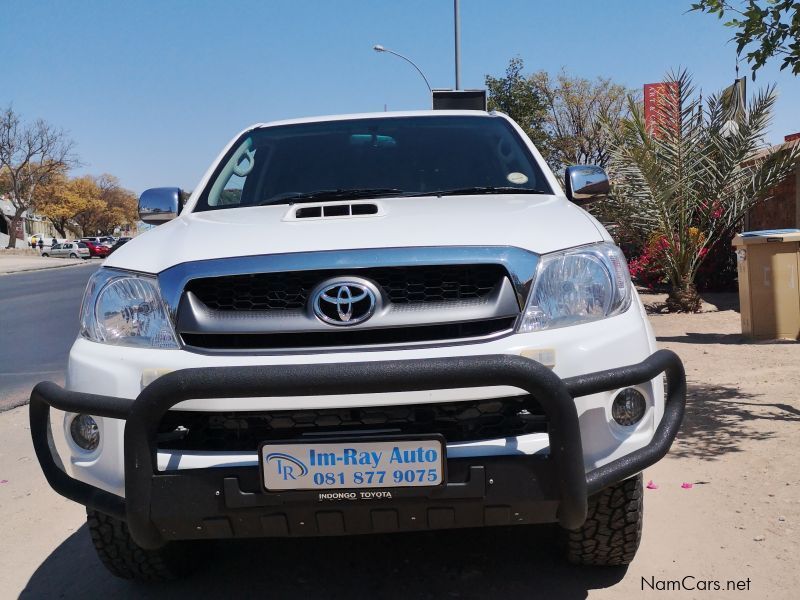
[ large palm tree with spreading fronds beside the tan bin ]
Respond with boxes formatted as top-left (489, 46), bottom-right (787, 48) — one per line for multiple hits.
top-left (601, 71), bottom-right (800, 312)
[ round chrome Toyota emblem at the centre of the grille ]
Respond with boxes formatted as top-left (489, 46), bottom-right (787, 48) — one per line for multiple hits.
top-left (312, 280), bottom-right (376, 325)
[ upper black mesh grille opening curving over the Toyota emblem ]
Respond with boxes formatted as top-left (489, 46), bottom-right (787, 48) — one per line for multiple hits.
top-left (186, 264), bottom-right (506, 311)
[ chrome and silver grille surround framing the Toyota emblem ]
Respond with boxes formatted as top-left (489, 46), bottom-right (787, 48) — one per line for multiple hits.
top-left (158, 246), bottom-right (539, 353)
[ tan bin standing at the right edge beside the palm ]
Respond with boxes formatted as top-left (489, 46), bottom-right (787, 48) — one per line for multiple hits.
top-left (733, 229), bottom-right (800, 340)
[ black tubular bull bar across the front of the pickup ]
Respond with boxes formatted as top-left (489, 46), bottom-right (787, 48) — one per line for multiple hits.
top-left (30, 350), bottom-right (686, 548)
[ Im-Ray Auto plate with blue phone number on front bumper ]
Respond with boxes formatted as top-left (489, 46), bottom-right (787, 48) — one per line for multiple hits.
top-left (258, 435), bottom-right (447, 492)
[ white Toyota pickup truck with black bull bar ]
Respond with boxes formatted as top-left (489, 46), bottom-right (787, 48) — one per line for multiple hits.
top-left (30, 111), bottom-right (686, 580)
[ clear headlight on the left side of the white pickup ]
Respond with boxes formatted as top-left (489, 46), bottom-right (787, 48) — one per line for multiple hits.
top-left (80, 269), bottom-right (178, 349)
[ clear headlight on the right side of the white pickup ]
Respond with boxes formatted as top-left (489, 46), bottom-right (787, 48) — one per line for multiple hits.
top-left (519, 243), bottom-right (632, 333)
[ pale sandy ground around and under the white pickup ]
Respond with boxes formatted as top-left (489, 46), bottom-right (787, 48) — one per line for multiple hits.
top-left (0, 297), bottom-right (800, 599)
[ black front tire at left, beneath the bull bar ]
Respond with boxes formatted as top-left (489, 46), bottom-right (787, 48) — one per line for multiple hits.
top-left (86, 509), bottom-right (199, 582)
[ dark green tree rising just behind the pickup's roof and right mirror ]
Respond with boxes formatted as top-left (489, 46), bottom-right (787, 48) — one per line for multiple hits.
top-left (486, 56), bottom-right (549, 158)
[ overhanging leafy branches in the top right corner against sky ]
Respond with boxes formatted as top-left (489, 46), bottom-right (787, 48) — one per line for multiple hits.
top-left (691, 0), bottom-right (800, 79)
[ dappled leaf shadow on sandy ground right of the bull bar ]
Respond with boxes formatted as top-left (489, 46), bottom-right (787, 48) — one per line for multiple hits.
top-left (670, 383), bottom-right (800, 460)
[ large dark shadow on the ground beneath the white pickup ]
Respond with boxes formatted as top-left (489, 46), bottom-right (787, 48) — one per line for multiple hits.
top-left (20, 526), bottom-right (626, 600)
